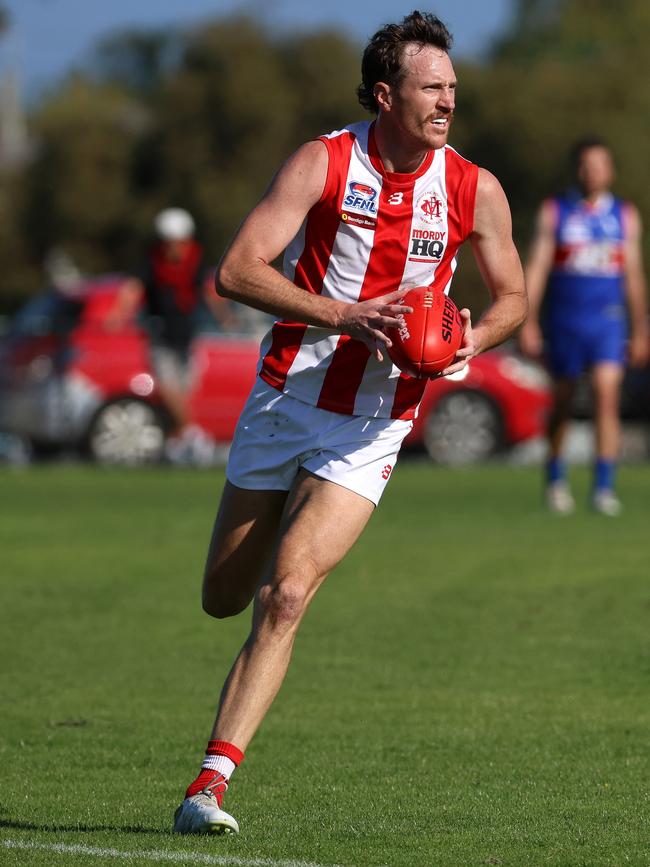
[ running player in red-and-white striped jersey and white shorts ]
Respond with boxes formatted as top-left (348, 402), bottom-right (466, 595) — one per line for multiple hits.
top-left (174, 12), bottom-right (526, 834)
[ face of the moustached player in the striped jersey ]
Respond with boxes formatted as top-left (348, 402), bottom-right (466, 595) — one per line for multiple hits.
top-left (382, 44), bottom-right (456, 149)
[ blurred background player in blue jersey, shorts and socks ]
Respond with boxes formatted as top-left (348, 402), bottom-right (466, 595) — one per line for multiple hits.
top-left (520, 138), bottom-right (648, 516)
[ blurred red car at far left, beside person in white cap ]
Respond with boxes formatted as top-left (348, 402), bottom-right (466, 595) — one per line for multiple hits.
top-left (0, 275), bottom-right (167, 464)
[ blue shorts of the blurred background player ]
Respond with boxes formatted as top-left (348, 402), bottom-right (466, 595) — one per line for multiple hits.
top-left (546, 317), bottom-right (627, 379)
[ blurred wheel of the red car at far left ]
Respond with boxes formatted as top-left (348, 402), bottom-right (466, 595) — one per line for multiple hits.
top-left (87, 398), bottom-right (165, 466)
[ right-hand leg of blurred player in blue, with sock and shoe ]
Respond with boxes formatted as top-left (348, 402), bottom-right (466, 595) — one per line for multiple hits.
top-left (591, 362), bottom-right (623, 517)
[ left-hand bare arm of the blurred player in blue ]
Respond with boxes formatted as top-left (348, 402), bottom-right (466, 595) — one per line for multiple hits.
top-left (519, 200), bottom-right (556, 358)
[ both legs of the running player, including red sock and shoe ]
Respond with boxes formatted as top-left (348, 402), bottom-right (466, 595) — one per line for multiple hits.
top-left (174, 471), bottom-right (374, 834)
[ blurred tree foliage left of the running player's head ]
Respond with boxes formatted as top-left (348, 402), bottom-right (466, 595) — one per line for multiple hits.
top-left (0, 17), bottom-right (362, 310)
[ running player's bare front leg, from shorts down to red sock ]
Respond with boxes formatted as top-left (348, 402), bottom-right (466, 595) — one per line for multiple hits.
top-left (212, 471), bottom-right (374, 750)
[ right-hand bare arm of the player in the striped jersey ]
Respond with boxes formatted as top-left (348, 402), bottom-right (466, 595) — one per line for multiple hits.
top-left (443, 169), bottom-right (528, 375)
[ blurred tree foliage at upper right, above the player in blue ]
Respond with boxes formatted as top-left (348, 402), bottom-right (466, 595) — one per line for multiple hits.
top-left (458, 0), bottom-right (650, 239)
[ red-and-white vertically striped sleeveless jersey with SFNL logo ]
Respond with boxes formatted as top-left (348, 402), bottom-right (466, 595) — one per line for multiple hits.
top-left (259, 121), bottom-right (478, 419)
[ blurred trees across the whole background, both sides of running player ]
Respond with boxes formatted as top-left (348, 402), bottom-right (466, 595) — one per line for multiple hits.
top-left (0, 0), bottom-right (650, 313)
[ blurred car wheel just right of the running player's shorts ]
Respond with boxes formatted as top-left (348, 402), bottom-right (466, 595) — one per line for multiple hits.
top-left (424, 391), bottom-right (503, 466)
